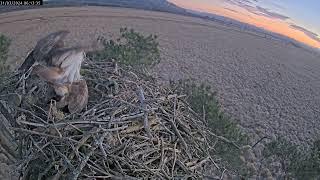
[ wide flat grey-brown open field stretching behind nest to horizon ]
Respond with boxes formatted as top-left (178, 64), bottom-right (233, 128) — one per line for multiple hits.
top-left (0, 7), bottom-right (320, 156)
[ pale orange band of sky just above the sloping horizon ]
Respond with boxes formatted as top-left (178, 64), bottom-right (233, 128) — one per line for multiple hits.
top-left (170, 0), bottom-right (320, 48)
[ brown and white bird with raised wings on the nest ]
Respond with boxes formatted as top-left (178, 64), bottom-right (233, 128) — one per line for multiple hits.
top-left (19, 31), bottom-right (88, 113)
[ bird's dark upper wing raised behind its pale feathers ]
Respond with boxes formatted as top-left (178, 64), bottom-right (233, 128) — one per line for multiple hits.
top-left (33, 31), bottom-right (69, 62)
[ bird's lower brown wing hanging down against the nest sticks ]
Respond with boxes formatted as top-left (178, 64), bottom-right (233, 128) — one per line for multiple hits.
top-left (66, 80), bottom-right (88, 113)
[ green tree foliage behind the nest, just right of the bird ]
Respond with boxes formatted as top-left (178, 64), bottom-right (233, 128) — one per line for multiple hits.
top-left (89, 28), bottom-right (160, 68)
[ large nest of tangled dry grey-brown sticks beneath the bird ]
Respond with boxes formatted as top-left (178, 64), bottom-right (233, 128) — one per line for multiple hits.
top-left (0, 59), bottom-right (224, 179)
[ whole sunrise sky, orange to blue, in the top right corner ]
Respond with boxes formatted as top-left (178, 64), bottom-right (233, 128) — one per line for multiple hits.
top-left (169, 0), bottom-right (320, 48)
